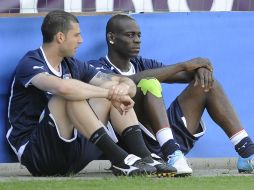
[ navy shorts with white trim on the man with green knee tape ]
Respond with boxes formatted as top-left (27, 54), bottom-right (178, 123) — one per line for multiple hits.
top-left (139, 99), bottom-right (205, 157)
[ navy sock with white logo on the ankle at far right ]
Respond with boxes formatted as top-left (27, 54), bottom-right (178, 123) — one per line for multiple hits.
top-left (235, 137), bottom-right (254, 158)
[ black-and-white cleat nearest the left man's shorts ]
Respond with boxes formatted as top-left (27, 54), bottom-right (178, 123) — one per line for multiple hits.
top-left (111, 154), bottom-right (157, 176)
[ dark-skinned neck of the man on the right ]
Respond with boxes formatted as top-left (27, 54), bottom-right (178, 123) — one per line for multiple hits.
top-left (108, 52), bottom-right (130, 72)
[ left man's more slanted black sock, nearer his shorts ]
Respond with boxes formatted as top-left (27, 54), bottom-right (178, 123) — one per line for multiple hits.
top-left (89, 127), bottom-right (128, 166)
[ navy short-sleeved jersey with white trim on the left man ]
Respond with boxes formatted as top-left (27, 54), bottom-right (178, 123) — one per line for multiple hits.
top-left (7, 48), bottom-right (98, 153)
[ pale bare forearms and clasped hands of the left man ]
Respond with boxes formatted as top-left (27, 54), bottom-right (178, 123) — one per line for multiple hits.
top-left (31, 73), bottom-right (136, 114)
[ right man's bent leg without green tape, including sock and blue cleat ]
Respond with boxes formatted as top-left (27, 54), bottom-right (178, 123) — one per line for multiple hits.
top-left (178, 81), bottom-right (254, 173)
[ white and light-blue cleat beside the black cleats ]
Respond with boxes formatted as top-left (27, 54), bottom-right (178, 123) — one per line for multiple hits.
top-left (167, 150), bottom-right (192, 177)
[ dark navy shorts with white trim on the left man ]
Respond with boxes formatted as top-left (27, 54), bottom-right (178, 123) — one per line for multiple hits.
top-left (21, 107), bottom-right (103, 176)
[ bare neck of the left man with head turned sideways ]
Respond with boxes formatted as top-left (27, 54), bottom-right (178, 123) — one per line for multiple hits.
top-left (42, 44), bottom-right (63, 71)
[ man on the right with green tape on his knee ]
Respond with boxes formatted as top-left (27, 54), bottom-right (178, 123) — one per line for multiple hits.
top-left (89, 14), bottom-right (254, 175)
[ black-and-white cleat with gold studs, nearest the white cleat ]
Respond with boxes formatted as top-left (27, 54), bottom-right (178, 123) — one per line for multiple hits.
top-left (142, 153), bottom-right (176, 177)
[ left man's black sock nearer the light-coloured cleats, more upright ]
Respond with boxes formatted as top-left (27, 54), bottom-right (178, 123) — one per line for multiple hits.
top-left (122, 125), bottom-right (151, 158)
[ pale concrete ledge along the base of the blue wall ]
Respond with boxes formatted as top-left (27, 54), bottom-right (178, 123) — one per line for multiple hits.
top-left (0, 158), bottom-right (237, 177)
